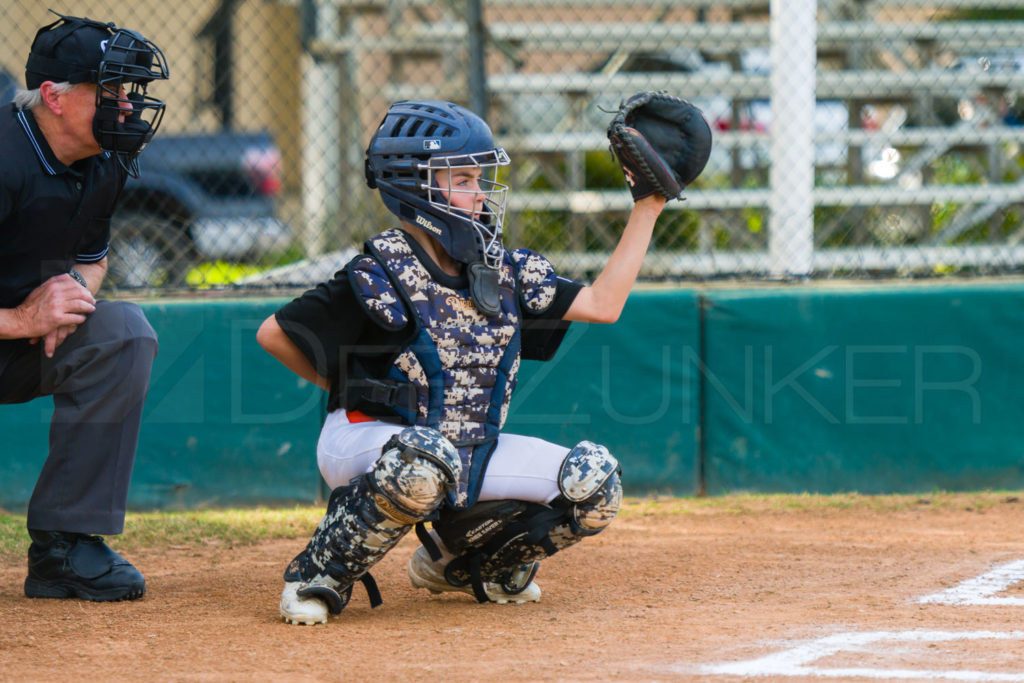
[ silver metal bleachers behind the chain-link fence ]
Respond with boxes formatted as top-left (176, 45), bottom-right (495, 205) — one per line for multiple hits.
top-left (310, 0), bottom-right (1024, 272)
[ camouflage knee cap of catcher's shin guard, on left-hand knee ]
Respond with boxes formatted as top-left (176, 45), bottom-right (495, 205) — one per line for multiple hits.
top-left (370, 427), bottom-right (462, 524)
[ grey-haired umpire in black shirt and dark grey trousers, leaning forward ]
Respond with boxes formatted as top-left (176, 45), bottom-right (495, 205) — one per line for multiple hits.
top-left (0, 14), bottom-right (168, 601)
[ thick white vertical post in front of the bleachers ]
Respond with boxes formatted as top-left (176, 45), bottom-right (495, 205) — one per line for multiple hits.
top-left (768, 0), bottom-right (817, 276)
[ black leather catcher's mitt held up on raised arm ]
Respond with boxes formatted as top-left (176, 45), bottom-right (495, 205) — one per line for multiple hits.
top-left (608, 92), bottom-right (711, 201)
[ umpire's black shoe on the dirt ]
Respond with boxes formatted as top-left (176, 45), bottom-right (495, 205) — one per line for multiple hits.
top-left (25, 531), bottom-right (145, 602)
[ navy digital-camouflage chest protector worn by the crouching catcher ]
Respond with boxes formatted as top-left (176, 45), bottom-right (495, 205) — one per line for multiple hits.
top-left (347, 229), bottom-right (556, 509)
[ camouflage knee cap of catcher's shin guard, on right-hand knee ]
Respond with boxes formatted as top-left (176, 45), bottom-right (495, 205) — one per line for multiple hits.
top-left (558, 441), bottom-right (623, 536)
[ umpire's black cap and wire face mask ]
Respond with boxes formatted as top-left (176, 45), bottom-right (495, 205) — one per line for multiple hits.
top-left (25, 12), bottom-right (169, 176)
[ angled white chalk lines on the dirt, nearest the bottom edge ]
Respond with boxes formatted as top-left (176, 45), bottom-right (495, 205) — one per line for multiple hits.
top-left (700, 631), bottom-right (1024, 683)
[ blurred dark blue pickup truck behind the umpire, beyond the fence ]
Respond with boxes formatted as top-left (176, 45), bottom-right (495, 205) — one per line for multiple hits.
top-left (0, 69), bottom-right (291, 288)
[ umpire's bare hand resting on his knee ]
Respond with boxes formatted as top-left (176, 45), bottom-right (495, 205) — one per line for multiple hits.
top-left (14, 273), bottom-right (96, 358)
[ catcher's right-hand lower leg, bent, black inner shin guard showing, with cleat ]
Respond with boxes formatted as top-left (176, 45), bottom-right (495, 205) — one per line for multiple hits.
top-left (409, 441), bottom-right (623, 602)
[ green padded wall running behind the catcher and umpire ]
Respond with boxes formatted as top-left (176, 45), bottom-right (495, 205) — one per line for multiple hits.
top-left (0, 282), bottom-right (1024, 510)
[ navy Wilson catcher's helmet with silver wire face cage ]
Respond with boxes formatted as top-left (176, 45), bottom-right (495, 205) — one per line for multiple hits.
top-left (366, 99), bottom-right (509, 269)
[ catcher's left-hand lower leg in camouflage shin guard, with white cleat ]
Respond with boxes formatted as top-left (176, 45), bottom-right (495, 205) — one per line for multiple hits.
top-left (281, 427), bottom-right (462, 624)
